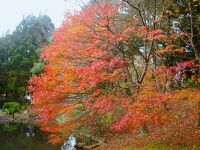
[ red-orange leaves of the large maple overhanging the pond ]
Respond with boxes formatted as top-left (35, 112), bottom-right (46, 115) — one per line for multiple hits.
top-left (29, 3), bottom-right (198, 143)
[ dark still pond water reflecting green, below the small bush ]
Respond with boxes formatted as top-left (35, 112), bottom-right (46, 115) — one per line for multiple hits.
top-left (0, 123), bottom-right (60, 150)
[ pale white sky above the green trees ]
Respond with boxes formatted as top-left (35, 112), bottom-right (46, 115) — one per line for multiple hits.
top-left (0, 0), bottom-right (89, 35)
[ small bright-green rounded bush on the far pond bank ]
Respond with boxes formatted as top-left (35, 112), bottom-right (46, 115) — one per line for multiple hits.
top-left (3, 102), bottom-right (21, 119)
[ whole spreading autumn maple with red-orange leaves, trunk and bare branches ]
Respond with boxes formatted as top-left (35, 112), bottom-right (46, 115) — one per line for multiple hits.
top-left (29, 0), bottom-right (198, 146)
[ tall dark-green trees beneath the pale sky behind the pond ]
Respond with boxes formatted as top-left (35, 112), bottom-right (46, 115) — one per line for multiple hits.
top-left (0, 15), bottom-right (55, 103)
